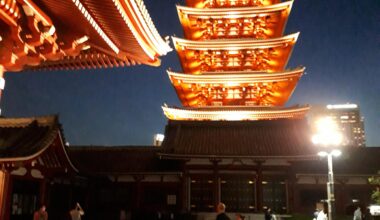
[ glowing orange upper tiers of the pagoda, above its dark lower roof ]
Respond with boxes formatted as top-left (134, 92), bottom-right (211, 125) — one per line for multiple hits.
top-left (163, 0), bottom-right (308, 121)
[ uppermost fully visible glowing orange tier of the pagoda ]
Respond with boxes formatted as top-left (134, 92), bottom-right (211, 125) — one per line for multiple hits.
top-left (177, 0), bottom-right (293, 40)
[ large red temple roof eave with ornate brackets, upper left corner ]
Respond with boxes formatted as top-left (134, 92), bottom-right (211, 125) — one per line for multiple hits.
top-left (0, 0), bottom-right (171, 71)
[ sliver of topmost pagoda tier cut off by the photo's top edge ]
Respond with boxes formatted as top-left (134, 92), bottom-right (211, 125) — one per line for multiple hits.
top-left (186, 0), bottom-right (281, 8)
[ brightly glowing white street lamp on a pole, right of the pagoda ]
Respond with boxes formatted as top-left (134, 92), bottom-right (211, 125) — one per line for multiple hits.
top-left (312, 117), bottom-right (343, 220)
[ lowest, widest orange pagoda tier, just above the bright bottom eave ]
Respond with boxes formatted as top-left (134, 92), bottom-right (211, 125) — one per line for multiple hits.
top-left (168, 68), bottom-right (305, 107)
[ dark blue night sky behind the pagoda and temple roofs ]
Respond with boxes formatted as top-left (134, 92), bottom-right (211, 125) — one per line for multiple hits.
top-left (1, 0), bottom-right (380, 146)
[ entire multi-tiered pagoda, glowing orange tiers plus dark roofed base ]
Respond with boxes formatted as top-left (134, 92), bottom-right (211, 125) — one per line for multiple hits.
top-left (159, 0), bottom-right (316, 215)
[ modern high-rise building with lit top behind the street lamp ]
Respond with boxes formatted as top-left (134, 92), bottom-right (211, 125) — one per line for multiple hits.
top-left (310, 104), bottom-right (365, 147)
